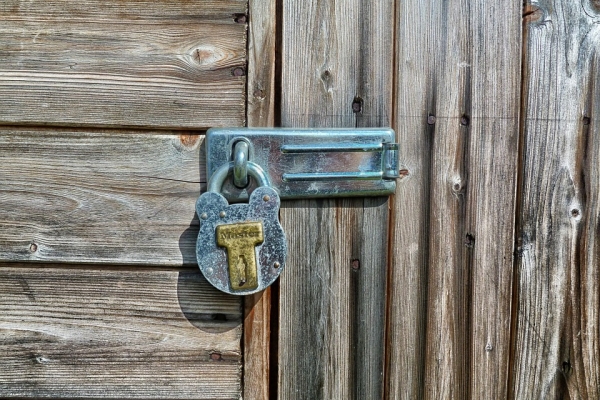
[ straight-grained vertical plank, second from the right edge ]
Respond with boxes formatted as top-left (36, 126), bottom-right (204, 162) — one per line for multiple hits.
top-left (472, 0), bottom-right (522, 399)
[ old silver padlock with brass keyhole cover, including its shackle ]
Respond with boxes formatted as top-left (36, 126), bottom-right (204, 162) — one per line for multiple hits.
top-left (196, 162), bottom-right (287, 295)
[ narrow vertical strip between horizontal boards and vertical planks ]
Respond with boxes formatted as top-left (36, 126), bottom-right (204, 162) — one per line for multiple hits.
top-left (244, 0), bottom-right (276, 400)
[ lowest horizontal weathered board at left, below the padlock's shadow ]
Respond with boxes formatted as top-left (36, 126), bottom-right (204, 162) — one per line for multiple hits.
top-left (0, 264), bottom-right (241, 400)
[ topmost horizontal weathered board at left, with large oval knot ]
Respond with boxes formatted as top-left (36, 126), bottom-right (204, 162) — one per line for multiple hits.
top-left (0, 0), bottom-right (246, 128)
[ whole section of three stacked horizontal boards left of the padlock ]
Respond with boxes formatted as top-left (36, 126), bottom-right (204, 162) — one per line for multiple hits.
top-left (0, 0), bottom-right (248, 399)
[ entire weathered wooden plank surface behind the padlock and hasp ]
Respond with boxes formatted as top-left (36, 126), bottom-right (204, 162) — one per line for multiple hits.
top-left (0, 0), bottom-right (600, 400)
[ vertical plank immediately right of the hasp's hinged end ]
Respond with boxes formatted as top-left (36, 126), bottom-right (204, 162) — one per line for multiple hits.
top-left (386, 1), bottom-right (437, 399)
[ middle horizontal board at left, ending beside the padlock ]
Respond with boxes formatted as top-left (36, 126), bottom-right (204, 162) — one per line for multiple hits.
top-left (0, 129), bottom-right (205, 265)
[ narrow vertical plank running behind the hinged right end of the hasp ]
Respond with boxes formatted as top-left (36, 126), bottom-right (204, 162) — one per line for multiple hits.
top-left (352, 1), bottom-right (394, 400)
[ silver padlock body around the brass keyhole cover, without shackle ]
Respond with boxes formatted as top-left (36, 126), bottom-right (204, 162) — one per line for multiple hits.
top-left (196, 186), bottom-right (287, 295)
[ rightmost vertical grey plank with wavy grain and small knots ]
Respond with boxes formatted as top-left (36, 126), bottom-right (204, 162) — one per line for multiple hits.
top-left (513, 0), bottom-right (600, 399)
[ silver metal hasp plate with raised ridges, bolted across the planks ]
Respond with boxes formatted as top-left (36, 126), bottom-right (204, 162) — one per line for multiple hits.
top-left (206, 128), bottom-right (398, 202)
